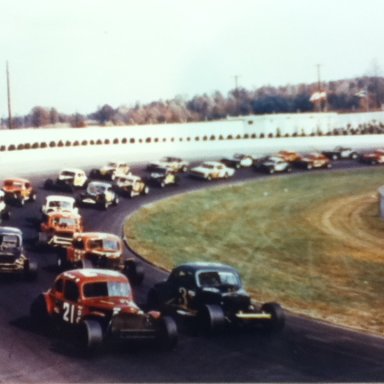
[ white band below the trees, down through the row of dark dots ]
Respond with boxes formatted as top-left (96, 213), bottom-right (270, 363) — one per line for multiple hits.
top-left (0, 112), bottom-right (384, 151)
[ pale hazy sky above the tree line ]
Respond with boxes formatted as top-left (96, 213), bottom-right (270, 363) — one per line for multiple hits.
top-left (0, 0), bottom-right (384, 117)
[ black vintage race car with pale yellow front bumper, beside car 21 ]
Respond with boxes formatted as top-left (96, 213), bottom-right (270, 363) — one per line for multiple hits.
top-left (147, 262), bottom-right (285, 332)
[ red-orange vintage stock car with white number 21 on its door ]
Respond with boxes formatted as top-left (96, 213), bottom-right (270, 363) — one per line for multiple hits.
top-left (30, 269), bottom-right (177, 351)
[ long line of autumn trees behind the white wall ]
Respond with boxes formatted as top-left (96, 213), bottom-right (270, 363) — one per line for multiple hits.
top-left (1, 76), bottom-right (384, 128)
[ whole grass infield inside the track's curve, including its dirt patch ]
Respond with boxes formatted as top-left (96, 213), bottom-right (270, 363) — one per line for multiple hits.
top-left (124, 168), bottom-right (384, 335)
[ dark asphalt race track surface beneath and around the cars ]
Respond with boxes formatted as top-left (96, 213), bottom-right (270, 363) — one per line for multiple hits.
top-left (0, 161), bottom-right (384, 383)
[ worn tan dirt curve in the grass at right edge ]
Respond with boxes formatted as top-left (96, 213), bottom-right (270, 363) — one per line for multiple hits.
top-left (307, 193), bottom-right (384, 262)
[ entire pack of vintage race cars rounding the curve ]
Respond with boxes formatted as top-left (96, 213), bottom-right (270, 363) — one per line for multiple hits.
top-left (0, 147), bottom-right (384, 350)
